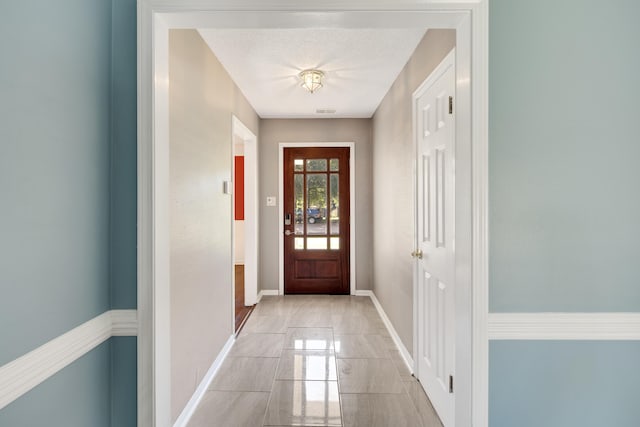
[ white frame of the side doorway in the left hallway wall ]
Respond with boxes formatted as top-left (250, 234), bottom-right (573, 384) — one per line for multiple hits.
top-left (231, 115), bottom-right (259, 308)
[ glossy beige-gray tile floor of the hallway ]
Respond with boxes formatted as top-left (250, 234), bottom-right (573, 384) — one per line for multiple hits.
top-left (189, 295), bottom-right (442, 427)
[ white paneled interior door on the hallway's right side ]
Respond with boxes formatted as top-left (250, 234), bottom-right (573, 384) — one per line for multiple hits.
top-left (413, 51), bottom-right (455, 427)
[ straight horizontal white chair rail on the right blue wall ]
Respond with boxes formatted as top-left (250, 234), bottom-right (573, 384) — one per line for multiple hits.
top-left (489, 313), bottom-right (640, 341)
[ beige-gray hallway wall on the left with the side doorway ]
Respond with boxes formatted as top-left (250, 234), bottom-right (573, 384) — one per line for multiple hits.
top-left (169, 30), bottom-right (258, 421)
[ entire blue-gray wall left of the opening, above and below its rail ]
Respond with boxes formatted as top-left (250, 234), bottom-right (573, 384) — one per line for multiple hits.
top-left (0, 0), bottom-right (136, 427)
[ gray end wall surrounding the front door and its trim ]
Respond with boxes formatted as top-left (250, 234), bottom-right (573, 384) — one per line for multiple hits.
top-left (258, 119), bottom-right (373, 290)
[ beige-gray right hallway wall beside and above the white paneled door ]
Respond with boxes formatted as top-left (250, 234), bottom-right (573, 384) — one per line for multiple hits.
top-left (373, 30), bottom-right (455, 351)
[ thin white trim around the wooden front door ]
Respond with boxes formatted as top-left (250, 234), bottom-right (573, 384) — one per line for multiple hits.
top-left (278, 142), bottom-right (357, 295)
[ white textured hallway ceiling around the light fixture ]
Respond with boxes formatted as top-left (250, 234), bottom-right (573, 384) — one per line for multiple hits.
top-left (199, 28), bottom-right (426, 118)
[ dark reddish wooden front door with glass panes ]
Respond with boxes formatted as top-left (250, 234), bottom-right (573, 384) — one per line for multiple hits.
top-left (282, 147), bottom-right (350, 294)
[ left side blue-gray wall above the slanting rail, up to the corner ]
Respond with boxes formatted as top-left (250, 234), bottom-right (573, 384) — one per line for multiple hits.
top-left (0, 0), bottom-right (111, 370)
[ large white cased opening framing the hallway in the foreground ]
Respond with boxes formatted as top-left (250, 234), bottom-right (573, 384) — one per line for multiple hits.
top-left (137, 0), bottom-right (489, 427)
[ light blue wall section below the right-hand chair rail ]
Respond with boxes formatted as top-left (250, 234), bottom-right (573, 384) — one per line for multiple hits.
top-left (489, 341), bottom-right (640, 427)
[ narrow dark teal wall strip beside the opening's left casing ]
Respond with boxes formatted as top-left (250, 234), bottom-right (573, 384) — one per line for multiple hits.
top-left (109, 0), bottom-right (138, 427)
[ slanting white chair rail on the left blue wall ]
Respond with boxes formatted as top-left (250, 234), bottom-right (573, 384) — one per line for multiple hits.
top-left (0, 310), bottom-right (138, 409)
